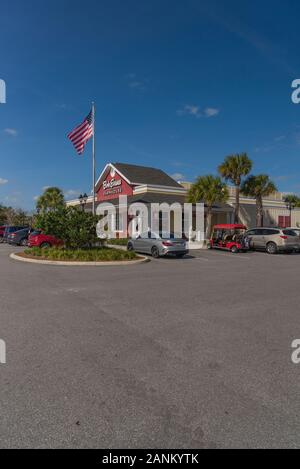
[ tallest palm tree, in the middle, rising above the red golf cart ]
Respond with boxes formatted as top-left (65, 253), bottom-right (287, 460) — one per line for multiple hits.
top-left (218, 153), bottom-right (252, 223)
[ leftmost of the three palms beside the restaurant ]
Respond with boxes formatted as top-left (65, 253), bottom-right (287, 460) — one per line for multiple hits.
top-left (188, 175), bottom-right (229, 238)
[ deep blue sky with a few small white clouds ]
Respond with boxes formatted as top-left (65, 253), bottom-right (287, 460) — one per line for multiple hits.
top-left (0, 0), bottom-right (300, 209)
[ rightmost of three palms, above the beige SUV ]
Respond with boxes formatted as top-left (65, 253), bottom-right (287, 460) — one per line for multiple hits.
top-left (241, 174), bottom-right (277, 227)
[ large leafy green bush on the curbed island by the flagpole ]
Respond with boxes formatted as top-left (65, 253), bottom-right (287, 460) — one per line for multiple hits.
top-left (36, 206), bottom-right (99, 249)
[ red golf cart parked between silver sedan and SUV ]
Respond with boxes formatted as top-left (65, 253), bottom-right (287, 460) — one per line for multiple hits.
top-left (210, 224), bottom-right (249, 254)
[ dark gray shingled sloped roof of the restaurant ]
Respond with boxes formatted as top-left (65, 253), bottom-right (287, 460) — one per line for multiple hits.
top-left (113, 163), bottom-right (182, 188)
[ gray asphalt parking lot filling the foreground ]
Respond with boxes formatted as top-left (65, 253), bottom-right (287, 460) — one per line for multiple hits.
top-left (0, 245), bottom-right (300, 448)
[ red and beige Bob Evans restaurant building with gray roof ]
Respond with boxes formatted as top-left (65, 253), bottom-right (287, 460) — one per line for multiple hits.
top-left (68, 163), bottom-right (300, 239)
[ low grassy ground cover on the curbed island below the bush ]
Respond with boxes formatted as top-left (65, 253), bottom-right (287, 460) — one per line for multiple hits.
top-left (24, 247), bottom-right (138, 262)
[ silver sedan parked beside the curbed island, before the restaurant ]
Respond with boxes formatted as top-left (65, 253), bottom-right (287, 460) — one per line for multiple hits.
top-left (127, 231), bottom-right (189, 258)
